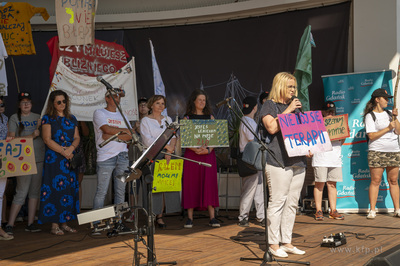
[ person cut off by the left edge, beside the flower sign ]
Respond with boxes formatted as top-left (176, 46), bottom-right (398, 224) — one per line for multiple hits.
top-left (0, 96), bottom-right (14, 240)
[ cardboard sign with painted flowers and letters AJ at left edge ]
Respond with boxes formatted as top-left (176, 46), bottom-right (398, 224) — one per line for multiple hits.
top-left (0, 138), bottom-right (37, 178)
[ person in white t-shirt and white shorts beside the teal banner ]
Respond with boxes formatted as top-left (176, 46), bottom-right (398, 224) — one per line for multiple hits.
top-left (312, 101), bottom-right (344, 221)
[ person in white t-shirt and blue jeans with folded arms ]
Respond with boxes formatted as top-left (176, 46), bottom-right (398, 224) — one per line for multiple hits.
top-left (92, 91), bottom-right (132, 235)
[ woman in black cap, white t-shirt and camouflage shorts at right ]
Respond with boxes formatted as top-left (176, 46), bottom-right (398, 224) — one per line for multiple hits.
top-left (364, 89), bottom-right (400, 219)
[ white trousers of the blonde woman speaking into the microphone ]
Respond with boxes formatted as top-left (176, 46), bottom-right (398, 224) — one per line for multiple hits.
top-left (265, 164), bottom-right (306, 245)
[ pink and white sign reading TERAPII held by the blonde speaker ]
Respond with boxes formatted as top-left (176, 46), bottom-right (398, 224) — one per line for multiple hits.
top-left (278, 111), bottom-right (332, 157)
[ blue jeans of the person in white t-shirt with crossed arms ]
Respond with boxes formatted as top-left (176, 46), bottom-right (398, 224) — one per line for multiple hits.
top-left (93, 152), bottom-right (129, 209)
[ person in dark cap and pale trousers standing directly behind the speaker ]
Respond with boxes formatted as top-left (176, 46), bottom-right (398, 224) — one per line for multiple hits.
top-left (238, 97), bottom-right (265, 227)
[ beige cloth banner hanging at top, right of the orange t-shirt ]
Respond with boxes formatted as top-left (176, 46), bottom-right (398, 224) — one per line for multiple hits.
top-left (55, 0), bottom-right (97, 46)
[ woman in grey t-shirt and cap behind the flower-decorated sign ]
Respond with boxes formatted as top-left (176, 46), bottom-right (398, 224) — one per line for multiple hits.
top-left (5, 92), bottom-right (44, 235)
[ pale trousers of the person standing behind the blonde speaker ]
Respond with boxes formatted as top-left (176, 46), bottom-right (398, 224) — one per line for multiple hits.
top-left (238, 171), bottom-right (265, 221)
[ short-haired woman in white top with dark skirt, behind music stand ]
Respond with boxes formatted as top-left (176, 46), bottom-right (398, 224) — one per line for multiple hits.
top-left (140, 95), bottom-right (181, 228)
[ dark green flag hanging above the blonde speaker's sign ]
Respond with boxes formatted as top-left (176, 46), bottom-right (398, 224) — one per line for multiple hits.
top-left (294, 25), bottom-right (316, 111)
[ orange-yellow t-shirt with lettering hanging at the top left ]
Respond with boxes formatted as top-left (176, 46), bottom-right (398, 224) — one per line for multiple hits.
top-left (0, 2), bottom-right (50, 55)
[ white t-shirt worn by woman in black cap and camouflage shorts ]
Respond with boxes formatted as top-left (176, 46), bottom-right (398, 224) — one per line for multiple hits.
top-left (365, 111), bottom-right (400, 152)
